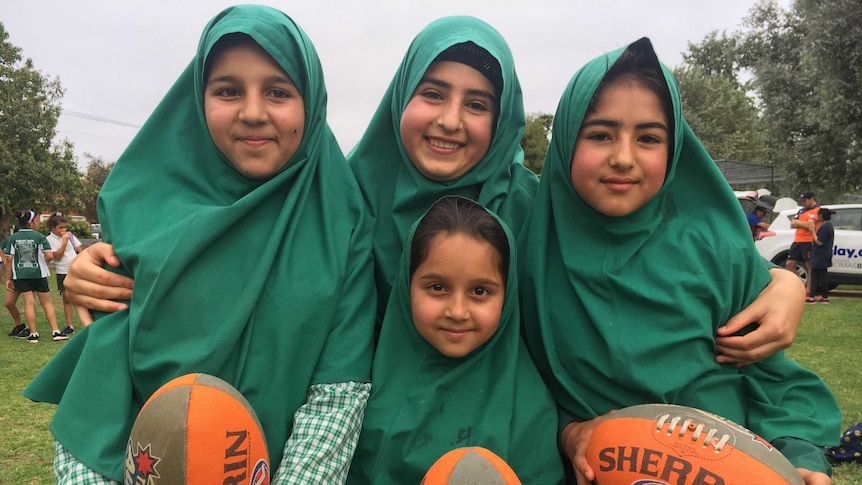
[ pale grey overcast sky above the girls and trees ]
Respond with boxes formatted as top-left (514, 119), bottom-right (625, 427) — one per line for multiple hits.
top-left (0, 0), bottom-right (790, 168)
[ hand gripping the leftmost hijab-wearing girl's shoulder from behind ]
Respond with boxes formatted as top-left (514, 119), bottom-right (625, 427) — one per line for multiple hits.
top-left (63, 242), bottom-right (134, 313)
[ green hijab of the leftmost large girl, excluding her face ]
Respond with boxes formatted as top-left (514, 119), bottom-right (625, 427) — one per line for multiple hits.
top-left (25, 6), bottom-right (375, 480)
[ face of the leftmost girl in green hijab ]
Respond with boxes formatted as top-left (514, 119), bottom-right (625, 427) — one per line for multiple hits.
top-left (204, 42), bottom-right (305, 179)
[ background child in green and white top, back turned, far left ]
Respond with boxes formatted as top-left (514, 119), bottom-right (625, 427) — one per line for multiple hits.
top-left (4, 211), bottom-right (69, 344)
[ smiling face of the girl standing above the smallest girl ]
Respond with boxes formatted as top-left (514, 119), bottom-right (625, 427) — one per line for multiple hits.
top-left (401, 61), bottom-right (499, 182)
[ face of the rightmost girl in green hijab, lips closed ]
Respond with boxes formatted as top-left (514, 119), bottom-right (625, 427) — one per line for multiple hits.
top-left (571, 79), bottom-right (670, 217)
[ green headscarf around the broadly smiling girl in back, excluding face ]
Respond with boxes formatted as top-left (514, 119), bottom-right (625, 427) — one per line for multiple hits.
top-left (347, 17), bottom-right (537, 319)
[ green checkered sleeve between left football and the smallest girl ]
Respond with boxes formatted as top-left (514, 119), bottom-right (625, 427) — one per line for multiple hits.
top-left (272, 382), bottom-right (371, 485)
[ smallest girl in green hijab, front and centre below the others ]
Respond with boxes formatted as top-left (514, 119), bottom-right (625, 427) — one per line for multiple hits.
top-left (348, 196), bottom-right (563, 485)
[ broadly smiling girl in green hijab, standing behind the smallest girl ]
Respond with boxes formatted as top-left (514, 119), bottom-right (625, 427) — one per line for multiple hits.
top-left (347, 16), bottom-right (538, 319)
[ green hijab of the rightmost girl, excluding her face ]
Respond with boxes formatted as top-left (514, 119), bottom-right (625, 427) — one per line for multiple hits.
top-left (519, 39), bottom-right (838, 450)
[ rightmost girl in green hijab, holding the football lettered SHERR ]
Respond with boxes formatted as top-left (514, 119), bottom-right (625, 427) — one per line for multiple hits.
top-left (519, 39), bottom-right (840, 484)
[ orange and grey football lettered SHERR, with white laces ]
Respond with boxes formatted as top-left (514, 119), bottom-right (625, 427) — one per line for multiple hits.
top-left (587, 404), bottom-right (804, 485)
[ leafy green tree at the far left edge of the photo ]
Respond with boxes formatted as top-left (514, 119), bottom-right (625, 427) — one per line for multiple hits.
top-left (0, 23), bottom-right (83, 230)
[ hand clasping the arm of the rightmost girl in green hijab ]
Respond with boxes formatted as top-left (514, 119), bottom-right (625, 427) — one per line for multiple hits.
top-left (715, 268), bottom-right (805, 366)
